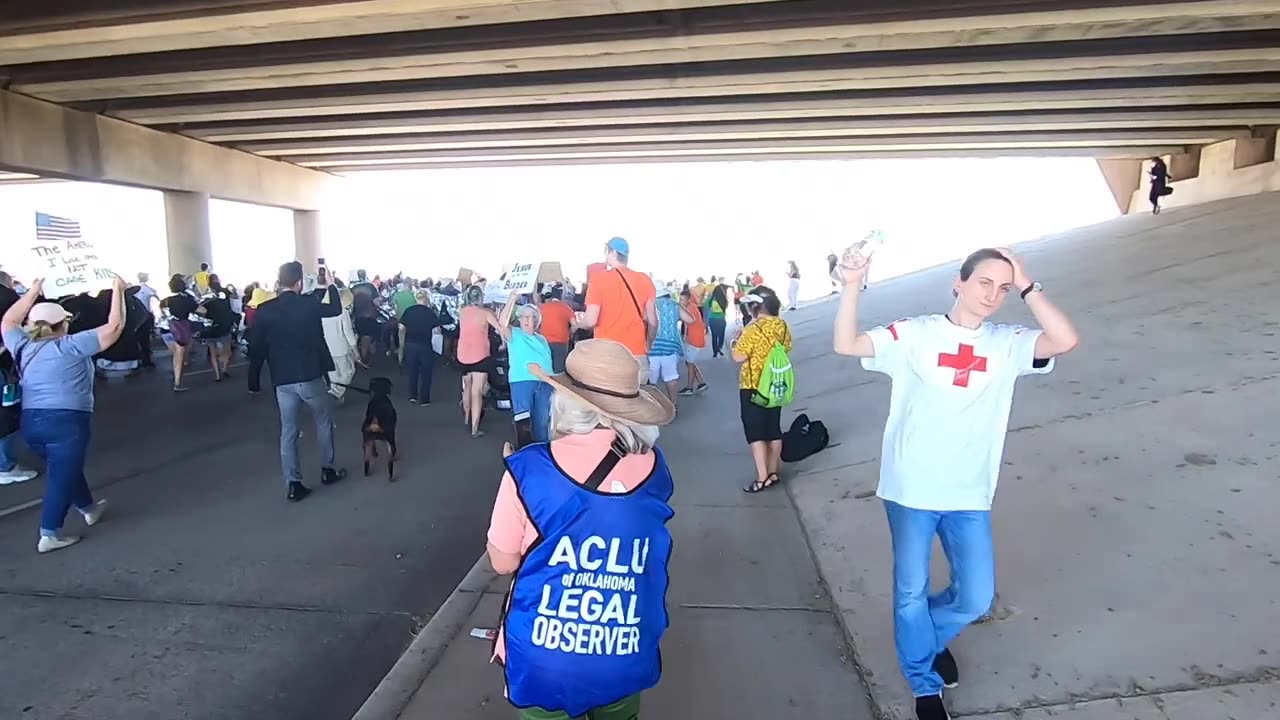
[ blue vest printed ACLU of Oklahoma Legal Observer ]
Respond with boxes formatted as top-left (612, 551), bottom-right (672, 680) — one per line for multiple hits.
top-left (503, 443), bottom-right (675, 717)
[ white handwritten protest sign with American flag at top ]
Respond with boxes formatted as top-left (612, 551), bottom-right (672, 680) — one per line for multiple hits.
top-left (29, 213), bottom-right (115, 299)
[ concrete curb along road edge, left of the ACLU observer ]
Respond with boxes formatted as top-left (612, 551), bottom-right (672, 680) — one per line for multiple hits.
top-left (351, 555), bottom-right (497, 720)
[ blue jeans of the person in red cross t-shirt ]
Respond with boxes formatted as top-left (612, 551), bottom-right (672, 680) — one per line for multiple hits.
top-left (884, 500), bottom-right (996, 697)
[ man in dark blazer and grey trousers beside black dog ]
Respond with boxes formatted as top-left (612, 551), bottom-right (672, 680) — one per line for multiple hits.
top-left (248, 261), bottom-right (347, 502)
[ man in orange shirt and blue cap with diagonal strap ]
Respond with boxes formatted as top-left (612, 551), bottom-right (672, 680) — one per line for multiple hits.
top-left (572, 237), bottom-right (658, 384)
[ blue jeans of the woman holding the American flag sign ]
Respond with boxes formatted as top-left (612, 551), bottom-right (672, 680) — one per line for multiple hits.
top-left (22, 410), bottom-right (93, 536)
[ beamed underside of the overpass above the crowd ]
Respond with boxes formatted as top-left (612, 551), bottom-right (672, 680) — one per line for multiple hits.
top-left (0, 0), bottom-right (1280, 173)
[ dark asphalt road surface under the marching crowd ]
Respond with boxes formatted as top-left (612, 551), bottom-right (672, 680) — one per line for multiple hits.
top-left (0, 353), bottom-right (509, 720)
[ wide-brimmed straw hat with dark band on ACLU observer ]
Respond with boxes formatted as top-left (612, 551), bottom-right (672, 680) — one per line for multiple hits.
top-left (529, 340), bottom-right (676, 425)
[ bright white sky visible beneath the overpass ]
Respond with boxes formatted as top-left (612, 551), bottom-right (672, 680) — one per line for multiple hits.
top-left (0, 158), bottom-right (1119, 297)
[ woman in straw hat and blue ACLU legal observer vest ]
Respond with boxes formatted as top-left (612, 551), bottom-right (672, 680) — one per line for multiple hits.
top-left (489, 340), bottom-right (676, 720)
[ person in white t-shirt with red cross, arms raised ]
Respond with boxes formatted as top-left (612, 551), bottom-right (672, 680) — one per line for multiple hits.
top-left (835, 249), bottom-right (1079, 720)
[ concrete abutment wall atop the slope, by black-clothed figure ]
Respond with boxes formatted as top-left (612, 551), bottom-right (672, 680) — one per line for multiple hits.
top-left (1131, 129), bottom-right (1280, 213)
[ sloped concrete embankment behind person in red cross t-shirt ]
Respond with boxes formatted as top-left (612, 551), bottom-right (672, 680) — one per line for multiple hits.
top-left (788, 193), bottom-right (1280, 720)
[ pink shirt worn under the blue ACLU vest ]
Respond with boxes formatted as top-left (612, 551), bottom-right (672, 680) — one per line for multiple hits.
top-left (489, 429), bottom-right (658, 659)
